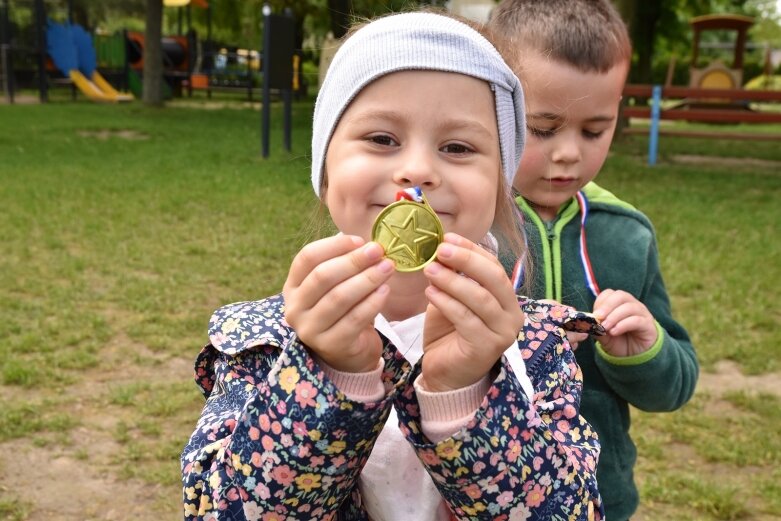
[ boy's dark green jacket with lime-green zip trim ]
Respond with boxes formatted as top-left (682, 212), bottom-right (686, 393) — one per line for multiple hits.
top-left (518, 183), bottom-right (699, 521)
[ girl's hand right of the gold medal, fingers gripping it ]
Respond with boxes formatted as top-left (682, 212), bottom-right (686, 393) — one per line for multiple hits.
top-left (422, 233), bottom-right (524, 392)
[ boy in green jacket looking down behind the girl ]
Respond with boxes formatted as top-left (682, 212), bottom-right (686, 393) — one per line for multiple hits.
top-left (488, 0), bottom-right (698, 521)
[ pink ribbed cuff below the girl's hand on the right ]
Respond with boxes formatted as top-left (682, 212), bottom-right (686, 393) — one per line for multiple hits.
top-left (413, 375), bottom-right (491, 443)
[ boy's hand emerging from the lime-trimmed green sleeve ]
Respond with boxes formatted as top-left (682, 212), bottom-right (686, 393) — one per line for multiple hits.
top-left (594, 289), bottom-right (658, 356)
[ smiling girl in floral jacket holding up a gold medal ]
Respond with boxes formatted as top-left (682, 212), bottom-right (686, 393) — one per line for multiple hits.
top-left (182, 13), bottom-right (602, 521)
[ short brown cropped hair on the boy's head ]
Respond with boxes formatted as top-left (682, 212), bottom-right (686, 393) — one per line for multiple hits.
top-left (488, 0), bottom-right (632, 73)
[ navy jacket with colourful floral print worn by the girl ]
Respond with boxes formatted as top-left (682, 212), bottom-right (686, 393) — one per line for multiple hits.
top-left (182, 295), bottom-right (604, 521)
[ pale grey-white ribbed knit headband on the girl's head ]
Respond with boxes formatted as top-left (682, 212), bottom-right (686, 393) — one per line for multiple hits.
top-left (312, 13), bottom-right (526, 196)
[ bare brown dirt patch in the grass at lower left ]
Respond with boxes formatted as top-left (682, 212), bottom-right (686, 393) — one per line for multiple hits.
top-left (0, 333), bottom-right (192, 521)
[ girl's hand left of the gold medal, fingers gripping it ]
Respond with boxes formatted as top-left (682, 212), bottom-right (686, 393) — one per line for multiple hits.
top-left (283, 235), bottom-right (394, 373)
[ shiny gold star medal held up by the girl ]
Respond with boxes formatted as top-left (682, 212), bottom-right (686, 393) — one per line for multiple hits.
top-left (372, 193), bottom-right (445, 272)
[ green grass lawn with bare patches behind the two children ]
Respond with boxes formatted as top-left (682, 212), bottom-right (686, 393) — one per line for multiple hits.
top-left (0, 95), bottom-right (781, 520)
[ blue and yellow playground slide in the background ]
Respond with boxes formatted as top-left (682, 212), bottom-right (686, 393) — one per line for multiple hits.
top-left (46, 20), bottom-right (133, 102)
